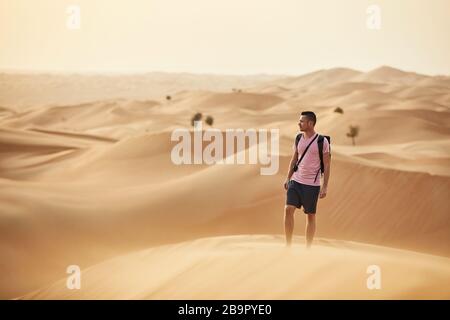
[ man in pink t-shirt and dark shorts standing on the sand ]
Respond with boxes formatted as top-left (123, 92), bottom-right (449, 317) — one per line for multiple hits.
top-left (284, 111), bottom-right (331, 248)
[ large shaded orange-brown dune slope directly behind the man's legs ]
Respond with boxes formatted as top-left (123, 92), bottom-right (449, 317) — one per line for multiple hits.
top-left (1, 136), bottom-right (450, 298)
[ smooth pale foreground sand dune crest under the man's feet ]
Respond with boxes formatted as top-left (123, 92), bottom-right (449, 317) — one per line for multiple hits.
top-left (21, 235), bottom-right (450, 299)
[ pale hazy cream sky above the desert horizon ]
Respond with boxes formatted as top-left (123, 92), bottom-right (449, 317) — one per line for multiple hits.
top-left (0, 0), bottom-right (450, 75)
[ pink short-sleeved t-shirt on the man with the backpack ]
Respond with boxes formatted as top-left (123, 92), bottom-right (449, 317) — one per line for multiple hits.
top-left (291, 133), bottom-right (330, 186)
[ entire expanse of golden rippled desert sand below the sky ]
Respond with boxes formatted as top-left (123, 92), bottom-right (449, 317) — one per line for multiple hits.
top-left (0, 67), bottom-right (450, 299)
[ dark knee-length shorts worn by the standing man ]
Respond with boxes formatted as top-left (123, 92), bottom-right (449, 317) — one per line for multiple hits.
top-left (286, 180), bottom-right (320, 213)
